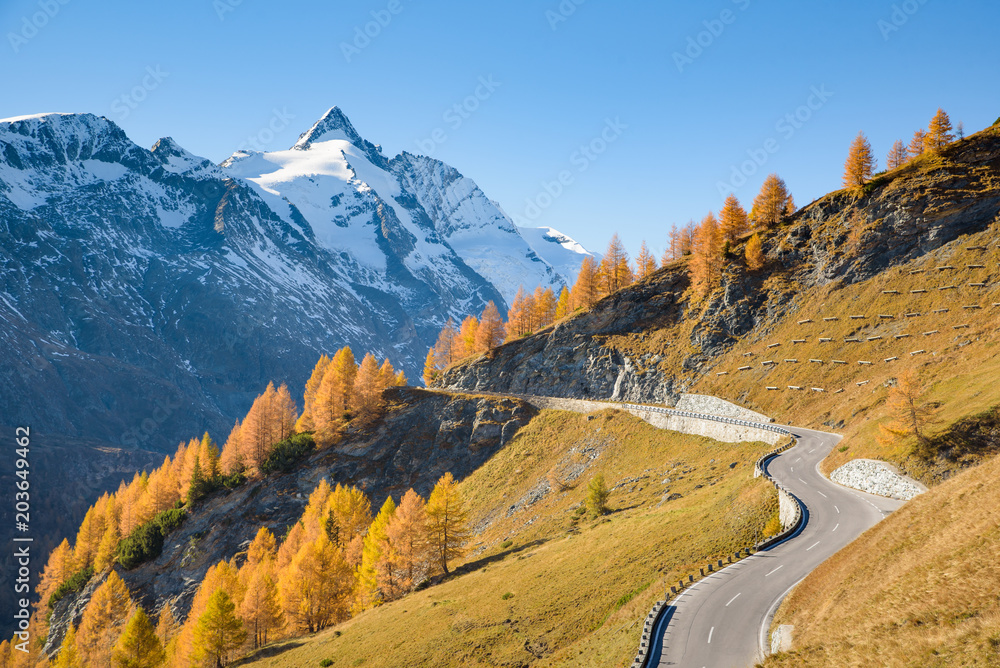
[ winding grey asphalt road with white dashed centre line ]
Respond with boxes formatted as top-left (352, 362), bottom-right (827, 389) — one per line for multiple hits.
top-left (648, 427), bottom-right (903, 668)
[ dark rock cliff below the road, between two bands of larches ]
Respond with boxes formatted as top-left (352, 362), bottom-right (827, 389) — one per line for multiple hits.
top-left (46, 388), bottom-right (537, 653)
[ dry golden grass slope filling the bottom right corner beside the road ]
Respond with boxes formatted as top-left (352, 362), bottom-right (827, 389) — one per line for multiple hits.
top-left (765, 444), bottom-right (1000, 668)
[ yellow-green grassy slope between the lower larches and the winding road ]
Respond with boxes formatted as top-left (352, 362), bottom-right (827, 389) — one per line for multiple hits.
top-left (246, 411), bottom-right (777, 667)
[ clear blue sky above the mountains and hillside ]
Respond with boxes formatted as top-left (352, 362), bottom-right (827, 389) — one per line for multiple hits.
top-left (0, 0), bottom-right (1000, 253)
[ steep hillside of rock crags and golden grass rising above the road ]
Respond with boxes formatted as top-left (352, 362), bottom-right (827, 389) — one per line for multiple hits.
top-left (440, 127), bottom-right (1000, 482)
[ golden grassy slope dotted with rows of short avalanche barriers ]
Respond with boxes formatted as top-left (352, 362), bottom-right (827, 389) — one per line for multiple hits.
top-left (692, 222), bottom-right (1000, 484)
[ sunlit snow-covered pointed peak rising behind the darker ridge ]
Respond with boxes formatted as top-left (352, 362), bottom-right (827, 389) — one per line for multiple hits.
top-left (222, 107), bottom-right (582, 302)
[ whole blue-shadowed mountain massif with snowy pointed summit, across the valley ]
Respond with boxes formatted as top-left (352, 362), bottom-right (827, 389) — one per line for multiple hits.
top-left (0, 108), bottom-right (585, 449)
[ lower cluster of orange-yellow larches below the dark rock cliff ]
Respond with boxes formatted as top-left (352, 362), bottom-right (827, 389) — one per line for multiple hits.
top-left (35, 444), bottom-right (469, 668)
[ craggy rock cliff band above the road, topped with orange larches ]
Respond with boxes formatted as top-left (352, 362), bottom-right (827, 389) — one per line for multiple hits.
top-left (439, 127), bottom-right (1000, 404)
